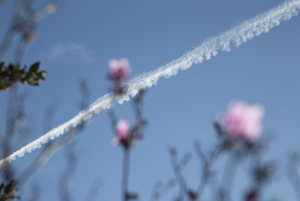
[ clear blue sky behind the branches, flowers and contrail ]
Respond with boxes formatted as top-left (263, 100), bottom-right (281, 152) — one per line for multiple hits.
top-left (0, 0), bottom-right (300, 201)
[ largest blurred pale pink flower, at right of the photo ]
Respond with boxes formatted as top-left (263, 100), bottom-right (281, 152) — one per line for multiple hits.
top-left (219, 101), bottom-right (264, 142)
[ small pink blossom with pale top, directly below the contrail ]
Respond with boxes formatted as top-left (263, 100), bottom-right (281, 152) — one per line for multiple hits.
top-left (112, 119), bottom-right (130, 146)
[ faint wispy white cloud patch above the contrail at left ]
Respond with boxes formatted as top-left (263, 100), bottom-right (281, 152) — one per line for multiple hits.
top-left (40, 43), bottom-right (96, 65)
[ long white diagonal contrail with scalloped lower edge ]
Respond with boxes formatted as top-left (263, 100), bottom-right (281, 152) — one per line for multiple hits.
top-left (0, 0), bottom-right (300, 167)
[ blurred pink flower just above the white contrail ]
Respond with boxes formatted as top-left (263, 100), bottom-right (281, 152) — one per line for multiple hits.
top-left (108, 58), bottom-right (131, 83)
